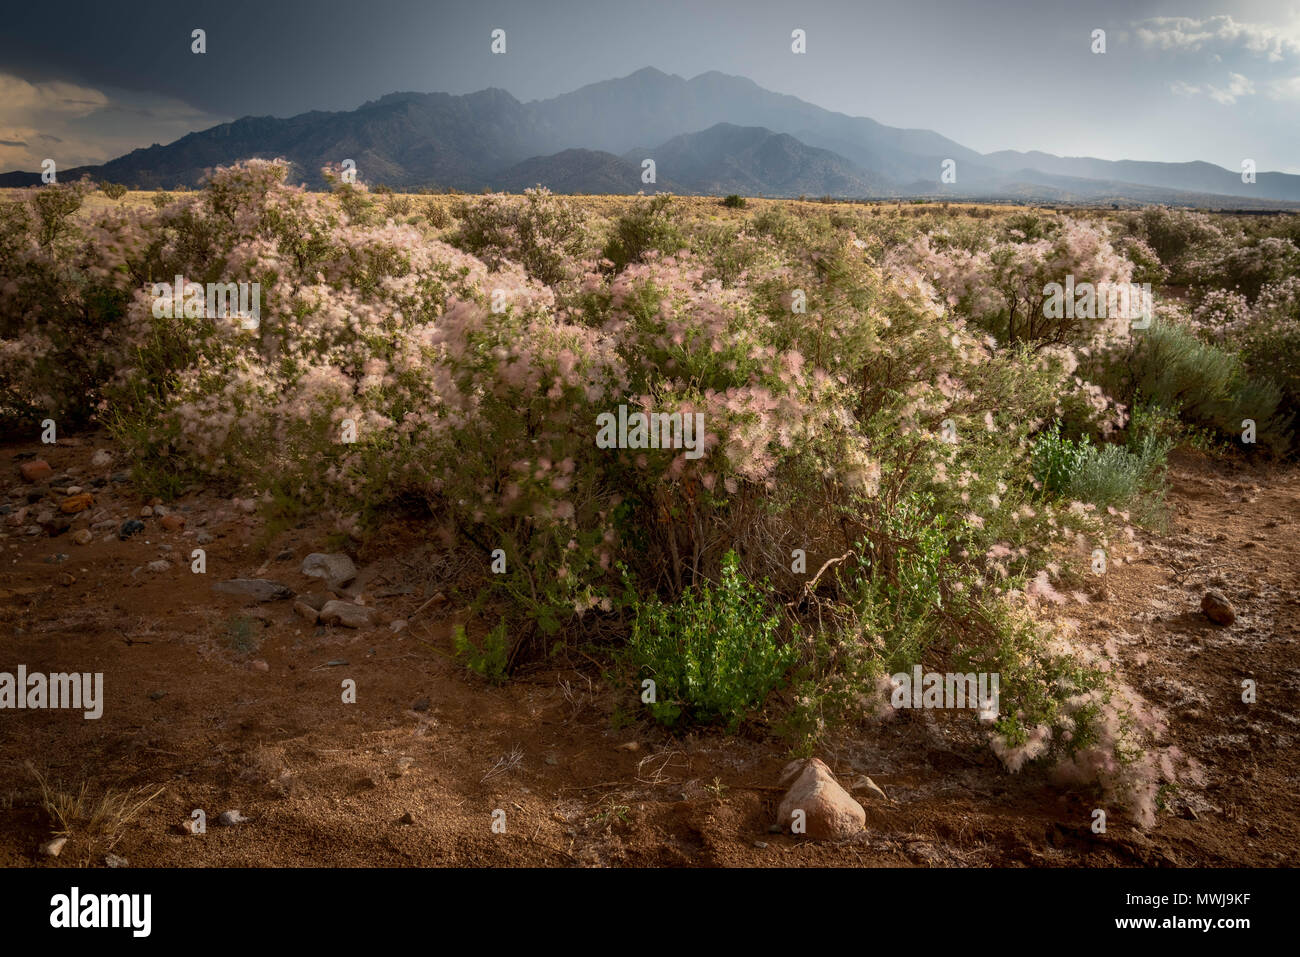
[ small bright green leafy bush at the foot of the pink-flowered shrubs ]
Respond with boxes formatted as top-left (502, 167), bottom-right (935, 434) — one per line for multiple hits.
top-left (627, 553), bottom-right (793, 728)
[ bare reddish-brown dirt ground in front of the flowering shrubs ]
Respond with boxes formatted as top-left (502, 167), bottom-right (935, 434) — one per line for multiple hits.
top-left (0, 436), bottom-right (1300, 867)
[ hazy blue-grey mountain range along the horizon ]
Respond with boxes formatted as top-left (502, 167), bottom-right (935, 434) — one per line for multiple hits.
top-left (0, 68), bottom-right (1300, 207)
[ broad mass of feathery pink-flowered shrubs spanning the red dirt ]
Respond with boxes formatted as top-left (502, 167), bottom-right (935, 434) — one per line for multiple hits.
top-left (0, 174), bottom-right (1279, 819)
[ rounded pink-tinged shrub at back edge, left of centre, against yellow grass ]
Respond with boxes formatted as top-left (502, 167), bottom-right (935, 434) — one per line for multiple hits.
top-left (451, 187), bottom-right (586, 285)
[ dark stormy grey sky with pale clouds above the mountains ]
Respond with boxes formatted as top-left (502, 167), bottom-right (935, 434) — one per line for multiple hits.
top-left (0, 0), bottom-right (1300, 173)
